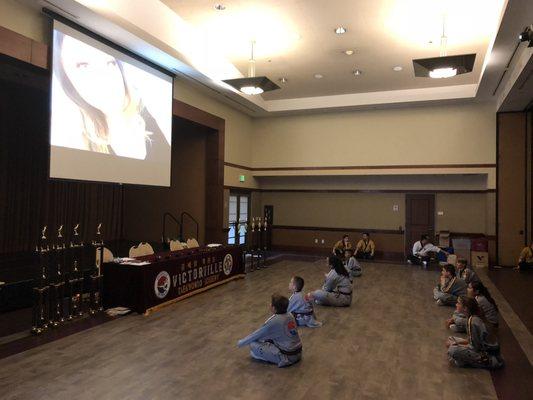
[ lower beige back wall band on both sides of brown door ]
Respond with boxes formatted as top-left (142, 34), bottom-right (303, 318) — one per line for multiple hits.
top-left (252, 192), bottom-right (495, 235)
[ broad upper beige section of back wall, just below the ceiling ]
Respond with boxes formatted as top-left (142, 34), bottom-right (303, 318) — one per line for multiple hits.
top-left (252, 104), bottom-right (496, 167)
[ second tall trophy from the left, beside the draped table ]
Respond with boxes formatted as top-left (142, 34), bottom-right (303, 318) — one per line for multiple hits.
top-left (50, 225), bottom-right (66, 328)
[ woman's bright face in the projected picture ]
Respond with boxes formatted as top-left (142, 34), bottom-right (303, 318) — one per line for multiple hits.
top-left (61, 36), bottom-right (128, 115)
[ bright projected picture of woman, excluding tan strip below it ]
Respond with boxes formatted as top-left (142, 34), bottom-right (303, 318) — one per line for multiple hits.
top-left (52, 31), bottom-right (170, 159)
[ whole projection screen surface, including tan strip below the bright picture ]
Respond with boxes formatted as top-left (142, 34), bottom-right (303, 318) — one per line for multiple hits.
top-left (50, 23), bottom-right (172, 186)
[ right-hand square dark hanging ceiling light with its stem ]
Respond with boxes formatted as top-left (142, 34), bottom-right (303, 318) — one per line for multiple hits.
top-left (413, 16), bottom-right (476, 79)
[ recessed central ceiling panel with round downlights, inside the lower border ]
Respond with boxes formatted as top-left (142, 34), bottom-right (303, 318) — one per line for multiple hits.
top-left (161, 0), bottom-right (504, 100)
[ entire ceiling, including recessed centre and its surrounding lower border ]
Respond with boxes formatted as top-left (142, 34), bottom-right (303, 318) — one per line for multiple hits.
top-left (31, 0), bottom-right (533, 113)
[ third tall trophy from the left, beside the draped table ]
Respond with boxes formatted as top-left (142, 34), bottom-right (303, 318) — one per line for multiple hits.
top-left (67, 223), bottom-right (83, 321)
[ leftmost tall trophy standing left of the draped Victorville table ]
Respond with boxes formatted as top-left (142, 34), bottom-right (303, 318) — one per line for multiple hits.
top-left (31, 225), bottom-right (50, 335)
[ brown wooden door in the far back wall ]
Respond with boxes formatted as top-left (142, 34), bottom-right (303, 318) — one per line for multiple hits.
top-left (405, 194), bottom-right (435, 255)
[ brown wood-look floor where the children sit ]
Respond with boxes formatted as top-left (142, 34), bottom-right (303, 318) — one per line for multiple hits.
top-left (0, 261), bottom-right (496, 400)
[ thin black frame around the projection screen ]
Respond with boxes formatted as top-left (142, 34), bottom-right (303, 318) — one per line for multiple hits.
top-left (42, 8), bottom-right (176, 189)
